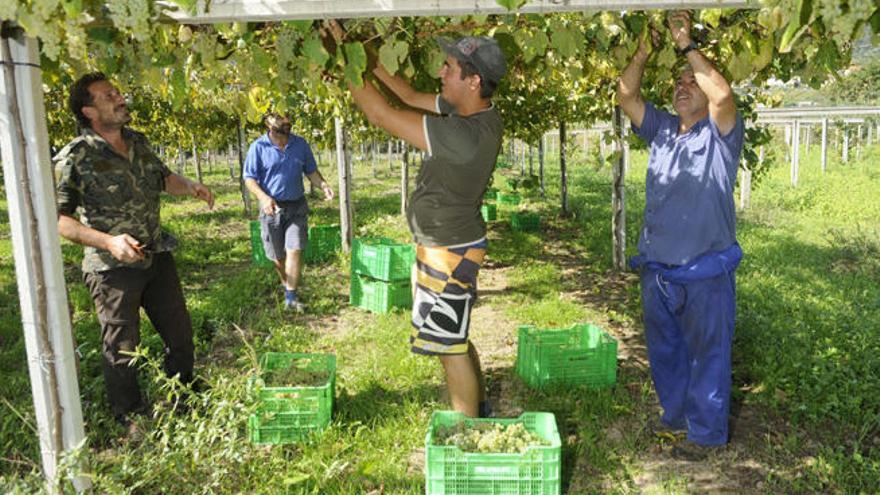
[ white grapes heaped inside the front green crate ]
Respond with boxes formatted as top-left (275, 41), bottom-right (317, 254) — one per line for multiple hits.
top-left (436, 422), bottom-right (548, 454)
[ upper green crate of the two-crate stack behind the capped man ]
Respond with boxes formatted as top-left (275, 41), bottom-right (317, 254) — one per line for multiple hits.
top-left (351, 237), bottom-right (416, 282)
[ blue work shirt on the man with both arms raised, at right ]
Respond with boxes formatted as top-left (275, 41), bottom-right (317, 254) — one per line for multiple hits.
top-left (633, 103), bottom-right (744, 265)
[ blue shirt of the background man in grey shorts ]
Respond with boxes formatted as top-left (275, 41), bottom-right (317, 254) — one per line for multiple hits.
top-left (244, 133), bottom-right (318, 201)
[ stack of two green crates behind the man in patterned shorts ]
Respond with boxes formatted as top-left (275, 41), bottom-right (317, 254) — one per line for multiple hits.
top-left (350, 237), bottom-right (416, 313)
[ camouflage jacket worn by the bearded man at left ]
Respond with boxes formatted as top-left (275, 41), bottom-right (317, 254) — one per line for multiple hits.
top-left (54, 128), bottom-right (171, 272)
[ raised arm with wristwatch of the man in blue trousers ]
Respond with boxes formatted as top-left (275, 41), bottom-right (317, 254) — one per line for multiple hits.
top-left (667, 11), bottom-right (736, 135)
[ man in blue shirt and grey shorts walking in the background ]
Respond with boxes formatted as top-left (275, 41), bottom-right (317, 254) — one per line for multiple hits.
top-left (244, 113), bottom-right (333, 312)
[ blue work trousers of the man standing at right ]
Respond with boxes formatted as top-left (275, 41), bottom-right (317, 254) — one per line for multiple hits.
top-left (641, 266), bottom-right (736, 445)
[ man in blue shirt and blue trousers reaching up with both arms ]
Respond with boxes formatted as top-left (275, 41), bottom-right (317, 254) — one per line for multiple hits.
top-left (617, 12), bottom-right (744, 460)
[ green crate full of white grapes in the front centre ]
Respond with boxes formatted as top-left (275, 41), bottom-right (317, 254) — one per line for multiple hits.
top-left (425, 411), bottom-right (562, 495)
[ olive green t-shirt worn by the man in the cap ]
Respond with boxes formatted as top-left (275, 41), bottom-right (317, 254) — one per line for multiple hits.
top-left (406, 96), bottom-right (504, 247)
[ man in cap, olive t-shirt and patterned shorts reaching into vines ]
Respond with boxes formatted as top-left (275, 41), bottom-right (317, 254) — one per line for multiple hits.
top-left (330, 22), bottom-right (507, 417)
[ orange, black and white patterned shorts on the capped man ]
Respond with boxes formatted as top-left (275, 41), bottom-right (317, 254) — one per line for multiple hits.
top-left (409, 240), bottom-right (487, 356)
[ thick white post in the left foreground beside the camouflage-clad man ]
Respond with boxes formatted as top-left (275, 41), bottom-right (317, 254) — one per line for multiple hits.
top-left (0, 34), bottom-right (90, 492)
